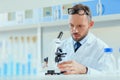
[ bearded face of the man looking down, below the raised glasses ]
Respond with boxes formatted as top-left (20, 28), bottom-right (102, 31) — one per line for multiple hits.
top-left (69, 14), bottom-right (92, 41)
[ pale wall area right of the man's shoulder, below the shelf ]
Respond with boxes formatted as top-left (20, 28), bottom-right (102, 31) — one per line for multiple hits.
top-left (91, 26), bottom-right (120, 57)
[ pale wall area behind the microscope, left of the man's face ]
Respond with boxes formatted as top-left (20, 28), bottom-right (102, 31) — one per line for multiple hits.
top-left (42, 26), bottom-right (70, 61)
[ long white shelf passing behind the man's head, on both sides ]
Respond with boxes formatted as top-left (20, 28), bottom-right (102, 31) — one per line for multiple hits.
top-left (0, 14), bottom-right (120, 32)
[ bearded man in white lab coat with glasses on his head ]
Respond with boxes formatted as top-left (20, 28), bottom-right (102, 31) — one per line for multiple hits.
top-left (58, 4), bottom-right (115, 74)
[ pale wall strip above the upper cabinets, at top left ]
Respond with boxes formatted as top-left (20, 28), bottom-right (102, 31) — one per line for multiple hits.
top-left (0, 0), bottom-right (90, 13)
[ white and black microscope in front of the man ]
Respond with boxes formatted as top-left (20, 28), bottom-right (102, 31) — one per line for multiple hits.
top-left (45, 32), bottom-right (67, 75)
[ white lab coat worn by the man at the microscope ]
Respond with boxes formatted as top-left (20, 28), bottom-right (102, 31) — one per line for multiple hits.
top-left (60, 33), bottom-right (116, 74)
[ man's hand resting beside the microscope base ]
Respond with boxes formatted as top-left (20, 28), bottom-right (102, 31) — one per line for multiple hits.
top-left (58, 61), bottom-right (87, 74)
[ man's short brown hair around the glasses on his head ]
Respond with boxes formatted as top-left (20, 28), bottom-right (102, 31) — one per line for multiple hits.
top-left (72, 4), bottom-right (92, 20)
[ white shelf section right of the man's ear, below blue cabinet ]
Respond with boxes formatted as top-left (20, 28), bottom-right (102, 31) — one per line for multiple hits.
top-left (93, 14), bottom-right (120, 28)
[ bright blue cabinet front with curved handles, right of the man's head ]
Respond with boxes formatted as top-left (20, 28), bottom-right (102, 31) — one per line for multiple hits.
top-left (83, 0), bottom-right (120, 16)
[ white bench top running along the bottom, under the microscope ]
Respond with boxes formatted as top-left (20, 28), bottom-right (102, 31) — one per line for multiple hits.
top-left (0, 73), bottom-right (120, 80)
